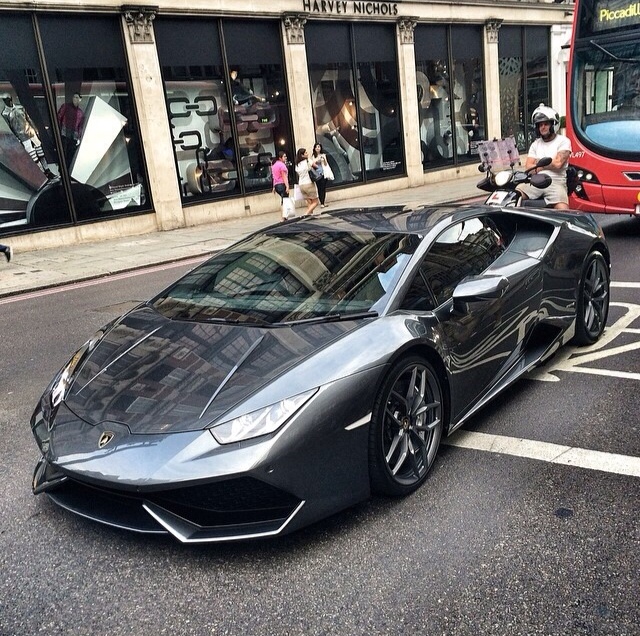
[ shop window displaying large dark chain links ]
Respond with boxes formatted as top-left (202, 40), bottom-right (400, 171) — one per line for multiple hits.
top-left (154, 17), bottom-right (294, 202)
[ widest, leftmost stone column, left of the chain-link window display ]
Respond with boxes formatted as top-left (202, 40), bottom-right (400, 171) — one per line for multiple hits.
top-left (122, 6), bottom-right (185, 230)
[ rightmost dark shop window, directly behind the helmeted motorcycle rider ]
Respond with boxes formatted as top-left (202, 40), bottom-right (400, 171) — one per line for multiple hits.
top-left (498, 26), bottom-right (553, 152)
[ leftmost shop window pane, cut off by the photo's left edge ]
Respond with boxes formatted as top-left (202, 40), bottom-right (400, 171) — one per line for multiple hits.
top-left (0, 15), bottom-right (71, 234)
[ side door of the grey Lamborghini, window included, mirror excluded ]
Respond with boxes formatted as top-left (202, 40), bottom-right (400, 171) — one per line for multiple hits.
top-left (402, 215), bottom-right (542, 420)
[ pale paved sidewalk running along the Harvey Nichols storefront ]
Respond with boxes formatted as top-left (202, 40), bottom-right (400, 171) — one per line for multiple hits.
top-left (0, 170), bottom-right (482, 298)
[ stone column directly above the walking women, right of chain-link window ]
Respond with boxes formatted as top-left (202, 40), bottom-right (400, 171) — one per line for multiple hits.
top-left (282, 14), bottom-right (316, 152)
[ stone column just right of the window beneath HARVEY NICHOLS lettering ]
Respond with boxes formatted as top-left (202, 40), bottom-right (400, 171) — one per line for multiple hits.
top-left (396, 17), bottom-right (424, 187)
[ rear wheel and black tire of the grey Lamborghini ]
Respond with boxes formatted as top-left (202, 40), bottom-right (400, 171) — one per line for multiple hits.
top-left (572, 250), bottom-right (611, 346)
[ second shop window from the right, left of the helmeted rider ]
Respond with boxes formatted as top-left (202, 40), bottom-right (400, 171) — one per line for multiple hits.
top-left (414, 24), bottom-right (486, 170)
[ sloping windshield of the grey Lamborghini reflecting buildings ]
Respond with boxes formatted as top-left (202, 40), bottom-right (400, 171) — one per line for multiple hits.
top-left (151, 230), bottom-right (419, 325)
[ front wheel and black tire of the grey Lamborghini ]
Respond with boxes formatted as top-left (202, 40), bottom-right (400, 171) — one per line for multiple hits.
top-left (369, 356), bottom-right (444, 497)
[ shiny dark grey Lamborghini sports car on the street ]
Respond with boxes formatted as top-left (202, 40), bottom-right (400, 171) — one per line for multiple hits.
top-left (31, 206), bottom-right (610, 542)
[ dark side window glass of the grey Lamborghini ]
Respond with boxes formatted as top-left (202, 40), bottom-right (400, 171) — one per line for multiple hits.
top-left (403, 217), bottom-right (506, 311)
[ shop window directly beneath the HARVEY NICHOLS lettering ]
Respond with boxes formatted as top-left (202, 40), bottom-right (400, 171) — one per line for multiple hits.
top-left (303, 22), bottom-right (405, 185)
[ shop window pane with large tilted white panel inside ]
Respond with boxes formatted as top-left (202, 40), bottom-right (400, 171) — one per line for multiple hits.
top-left (39, 16), bottom-right (148, 220)
